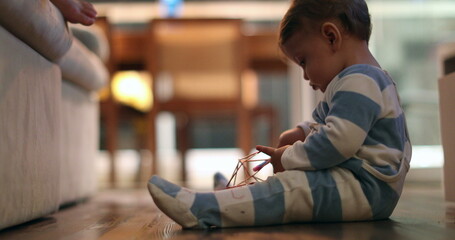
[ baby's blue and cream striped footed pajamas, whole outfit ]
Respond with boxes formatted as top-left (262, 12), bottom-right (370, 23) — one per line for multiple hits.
top-left (149, 65), bottom-right (411, 228)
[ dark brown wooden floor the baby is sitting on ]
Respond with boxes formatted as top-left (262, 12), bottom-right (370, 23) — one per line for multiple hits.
top-left (0, 184), bottom-right (455, 240)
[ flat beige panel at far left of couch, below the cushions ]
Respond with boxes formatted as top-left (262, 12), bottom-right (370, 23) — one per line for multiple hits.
top-left (0, 24), bottom-right (61, 231)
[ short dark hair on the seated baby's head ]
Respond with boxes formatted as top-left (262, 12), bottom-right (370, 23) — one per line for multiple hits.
top-left (279, 0), bottom-right (371, 46)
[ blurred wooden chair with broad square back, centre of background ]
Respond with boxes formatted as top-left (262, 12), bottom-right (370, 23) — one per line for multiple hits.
top-left (146, 19), bottom-right (277, 181)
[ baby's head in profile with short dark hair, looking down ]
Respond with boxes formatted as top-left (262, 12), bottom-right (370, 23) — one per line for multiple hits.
top-left (279, 0), bottom-right (371, 92)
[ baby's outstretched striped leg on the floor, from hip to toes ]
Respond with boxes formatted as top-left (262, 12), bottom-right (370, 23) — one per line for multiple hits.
top-left (148, 168), bottom-right (378, 228)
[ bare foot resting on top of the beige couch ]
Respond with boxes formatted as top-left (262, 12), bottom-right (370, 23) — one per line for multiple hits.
top-left (51, 0), bottom-right (97, 26)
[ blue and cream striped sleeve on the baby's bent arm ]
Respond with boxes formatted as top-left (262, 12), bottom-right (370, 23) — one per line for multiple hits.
top-left (281, 74), bottom-right (383, 170)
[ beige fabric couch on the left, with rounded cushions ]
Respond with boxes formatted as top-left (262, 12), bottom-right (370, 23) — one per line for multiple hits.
top-left (0, 0), bottom-right (108, 229)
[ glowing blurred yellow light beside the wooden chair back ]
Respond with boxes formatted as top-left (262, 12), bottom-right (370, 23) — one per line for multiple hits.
top-left (111, 71), bottom-right (153, 112)
